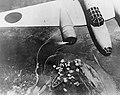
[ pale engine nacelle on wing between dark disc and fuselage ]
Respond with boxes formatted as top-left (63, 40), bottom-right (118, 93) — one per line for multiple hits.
top-left (60, 9), bottom-right (77, 45)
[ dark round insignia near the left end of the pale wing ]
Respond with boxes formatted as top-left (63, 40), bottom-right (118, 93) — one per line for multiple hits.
top-left (5, 12), bottom-right (22, 23)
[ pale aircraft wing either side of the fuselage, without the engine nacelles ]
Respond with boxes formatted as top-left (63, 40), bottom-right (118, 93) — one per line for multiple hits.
top-left (0, 0), bottom-right (115, 27)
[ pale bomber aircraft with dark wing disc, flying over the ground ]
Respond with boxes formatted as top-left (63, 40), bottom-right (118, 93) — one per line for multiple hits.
top-left (0, 0), bottom-right (120, 56)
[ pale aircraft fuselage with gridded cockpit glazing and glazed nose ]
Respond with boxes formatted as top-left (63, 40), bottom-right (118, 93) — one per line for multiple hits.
top-left (80, 0), bottom-right (112, 56)
